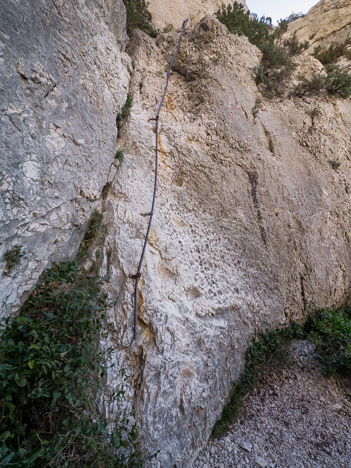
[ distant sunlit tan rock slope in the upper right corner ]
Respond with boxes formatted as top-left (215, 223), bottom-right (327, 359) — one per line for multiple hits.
top-left (287, 0), bottom-right (351, 54)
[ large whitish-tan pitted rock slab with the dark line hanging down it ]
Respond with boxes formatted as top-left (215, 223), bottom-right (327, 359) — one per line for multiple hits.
top-left (105, 13), bottom-right (351, 468)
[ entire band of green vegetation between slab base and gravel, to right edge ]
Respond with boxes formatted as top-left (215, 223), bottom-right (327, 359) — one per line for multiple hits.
top-left (212, 308), bottom-right (351, 438)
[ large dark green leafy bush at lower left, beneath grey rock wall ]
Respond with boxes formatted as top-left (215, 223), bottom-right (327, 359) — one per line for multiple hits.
top-left (0, 212), bottom-right (146, 468)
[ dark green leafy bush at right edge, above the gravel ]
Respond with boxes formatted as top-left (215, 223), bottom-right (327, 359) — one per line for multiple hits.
top-left (308, 309), bottom-right (351, 377)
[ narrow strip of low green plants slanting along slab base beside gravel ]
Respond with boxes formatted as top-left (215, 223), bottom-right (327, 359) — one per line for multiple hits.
top-left (212, 322), bottom-right (304, 438)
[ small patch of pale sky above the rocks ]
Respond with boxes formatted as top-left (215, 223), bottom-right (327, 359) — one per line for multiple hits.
top-left (246, 0), bottom-right (318, 24)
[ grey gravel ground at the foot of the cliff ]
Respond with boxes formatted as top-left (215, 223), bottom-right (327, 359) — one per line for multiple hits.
top-left (194, 341), bottom-right (351, 468)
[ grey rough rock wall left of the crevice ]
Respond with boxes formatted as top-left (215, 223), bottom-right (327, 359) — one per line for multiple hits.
top-left (0, 0), bottom-right (131, 312)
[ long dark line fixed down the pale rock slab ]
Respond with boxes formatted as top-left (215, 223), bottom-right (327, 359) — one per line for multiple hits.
top-left (129, 18), bottom-right (189, 341)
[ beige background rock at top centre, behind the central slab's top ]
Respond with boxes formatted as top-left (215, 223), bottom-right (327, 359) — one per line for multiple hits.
top-left (147, 0), bottom-right (247, 31)
